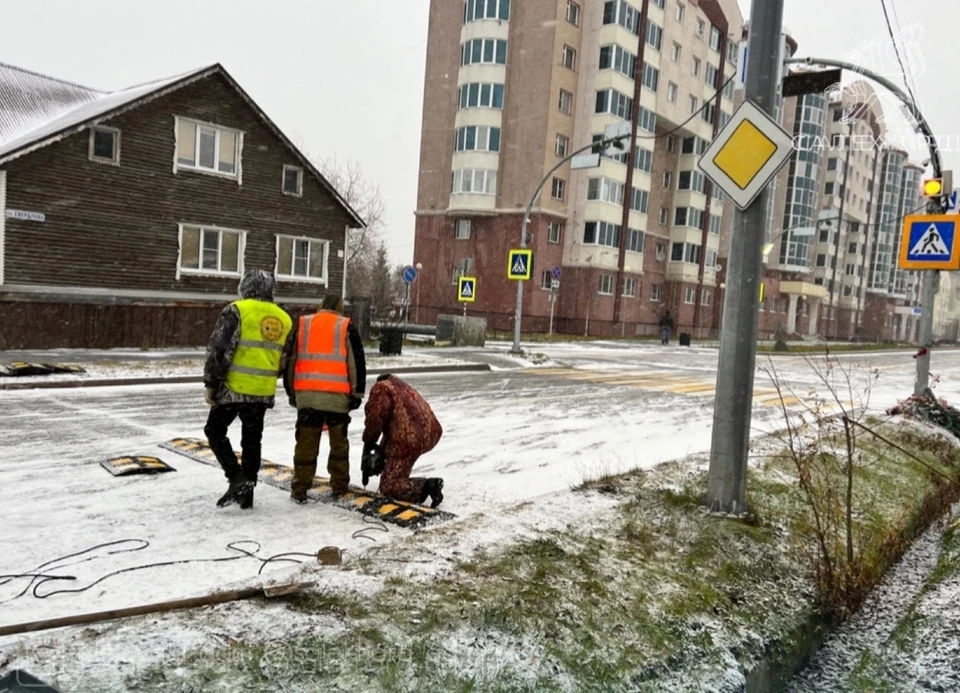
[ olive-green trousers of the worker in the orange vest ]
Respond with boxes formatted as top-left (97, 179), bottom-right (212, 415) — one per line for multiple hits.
top-left (290, 409), bottom-right (350, 494)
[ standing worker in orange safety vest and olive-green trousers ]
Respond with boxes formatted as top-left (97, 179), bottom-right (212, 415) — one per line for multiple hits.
top-left (283, 296), bottom-right (367, 503)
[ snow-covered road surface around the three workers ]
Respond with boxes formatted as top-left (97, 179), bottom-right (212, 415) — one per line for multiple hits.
top-left (0, 336), bottom-right (960, 688)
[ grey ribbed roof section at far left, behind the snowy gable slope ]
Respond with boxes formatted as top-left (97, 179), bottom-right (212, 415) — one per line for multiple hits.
top-left (0, 63), bottom-right (103, 147)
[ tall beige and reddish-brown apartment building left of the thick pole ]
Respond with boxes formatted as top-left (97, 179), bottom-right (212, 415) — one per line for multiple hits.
top-left (414, 0), bottom-right (743, 335)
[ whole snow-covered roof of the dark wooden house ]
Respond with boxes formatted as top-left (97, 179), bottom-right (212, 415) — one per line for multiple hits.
top-left (0, 64), bottom-right (216, 162)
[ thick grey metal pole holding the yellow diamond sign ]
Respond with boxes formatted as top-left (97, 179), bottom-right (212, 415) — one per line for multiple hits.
top-left (706, 0), bottom-right (783, 514)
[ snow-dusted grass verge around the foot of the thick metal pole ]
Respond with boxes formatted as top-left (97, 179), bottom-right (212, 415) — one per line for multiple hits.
top-left (90, 414), bottom-right (956, 691)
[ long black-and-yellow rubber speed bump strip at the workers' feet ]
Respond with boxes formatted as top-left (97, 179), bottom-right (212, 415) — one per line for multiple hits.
top-left (160, 438), bottom-right (456, 528)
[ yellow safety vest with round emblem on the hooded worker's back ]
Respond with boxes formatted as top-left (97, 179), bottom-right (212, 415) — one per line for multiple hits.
top-left (227, 298), bottom-right (293, 397)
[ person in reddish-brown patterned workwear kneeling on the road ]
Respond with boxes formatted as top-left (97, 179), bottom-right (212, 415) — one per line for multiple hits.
top-left (363, 373), bottom-right (443, 508)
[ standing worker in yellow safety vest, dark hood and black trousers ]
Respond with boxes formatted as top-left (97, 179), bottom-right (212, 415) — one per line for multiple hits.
top-left (203, 270), bottom-right (293, 510)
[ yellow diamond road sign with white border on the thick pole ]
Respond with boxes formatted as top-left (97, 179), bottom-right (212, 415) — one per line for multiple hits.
top-left (699, 101), bottom-right (793, 209)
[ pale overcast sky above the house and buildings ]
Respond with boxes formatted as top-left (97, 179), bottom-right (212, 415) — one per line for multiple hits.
top-left (0, 0), bottom-right (960, 262)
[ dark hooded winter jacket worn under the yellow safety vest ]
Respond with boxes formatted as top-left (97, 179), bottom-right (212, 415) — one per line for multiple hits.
top-left (203, 270), bottom-right (276, 407)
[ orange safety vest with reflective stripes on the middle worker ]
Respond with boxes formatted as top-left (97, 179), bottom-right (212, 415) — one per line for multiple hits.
top-left (293, 310), bottom-right (351, 395)
